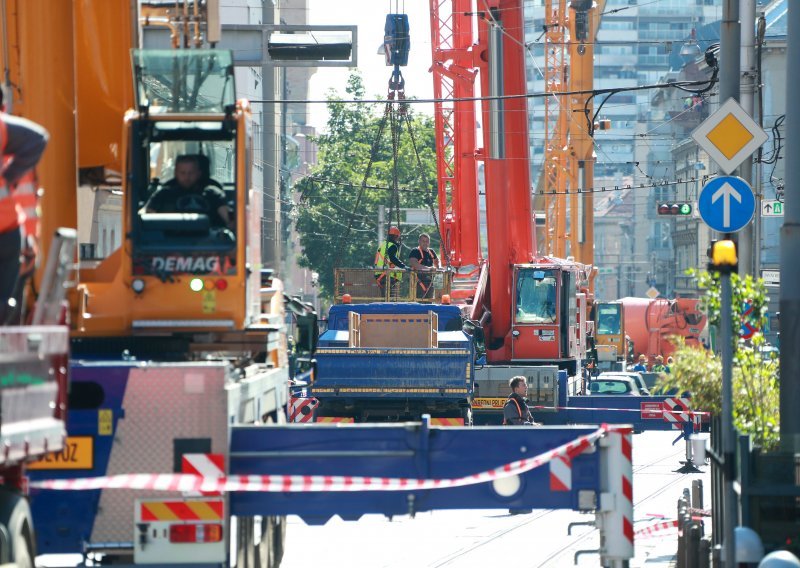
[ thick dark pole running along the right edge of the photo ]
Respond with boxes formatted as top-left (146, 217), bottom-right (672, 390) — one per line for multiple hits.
top-left (780, 2), bottom-right (800, 452)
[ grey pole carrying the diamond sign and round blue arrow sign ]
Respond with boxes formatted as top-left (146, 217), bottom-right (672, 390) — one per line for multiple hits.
top-left (719, 0), bottom-right (736, 568)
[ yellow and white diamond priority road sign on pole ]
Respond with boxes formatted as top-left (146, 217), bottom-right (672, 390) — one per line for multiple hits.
top-left (692, 99), bottom-right (768, 174)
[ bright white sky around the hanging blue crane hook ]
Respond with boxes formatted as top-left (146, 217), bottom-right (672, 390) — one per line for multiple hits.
top-left (308, 0), bottom-right (433, 131)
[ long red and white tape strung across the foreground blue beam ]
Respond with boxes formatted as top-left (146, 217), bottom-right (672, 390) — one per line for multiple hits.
top-left (30, 424), bottom-right (615, 493)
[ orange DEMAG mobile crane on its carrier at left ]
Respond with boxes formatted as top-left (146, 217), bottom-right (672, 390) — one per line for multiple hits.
top-left (2, 0), bottom-right (296, 566)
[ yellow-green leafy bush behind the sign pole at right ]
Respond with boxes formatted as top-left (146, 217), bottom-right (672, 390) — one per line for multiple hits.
top-left (659, 272), bottom-right (780, 450)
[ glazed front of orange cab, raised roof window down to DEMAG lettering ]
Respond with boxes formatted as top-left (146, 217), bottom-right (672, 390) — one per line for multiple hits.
top-left (128, 51), bottom-right (237, 279)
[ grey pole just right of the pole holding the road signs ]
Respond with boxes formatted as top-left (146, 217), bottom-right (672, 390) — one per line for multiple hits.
top-left (736, 0), bottom-right (761, 277)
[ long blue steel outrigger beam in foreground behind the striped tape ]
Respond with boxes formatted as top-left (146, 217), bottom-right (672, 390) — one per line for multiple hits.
top-left (230, 423), bottom-right (600, 524)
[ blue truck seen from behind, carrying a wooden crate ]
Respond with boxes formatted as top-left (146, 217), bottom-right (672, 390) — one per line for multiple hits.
top-left (309, 303), bottom-right (474, 424)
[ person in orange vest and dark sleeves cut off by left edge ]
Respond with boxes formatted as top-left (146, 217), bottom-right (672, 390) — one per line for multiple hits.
top-left (0, 86), bottom-right (49, 324)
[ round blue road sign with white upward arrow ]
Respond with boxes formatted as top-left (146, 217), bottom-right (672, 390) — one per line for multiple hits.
top-left (697, 176), bottom-right (756, 233)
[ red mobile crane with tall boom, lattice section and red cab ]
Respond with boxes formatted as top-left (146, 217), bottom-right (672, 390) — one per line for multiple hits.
top-left (431, 0), bottom-right (592, 418)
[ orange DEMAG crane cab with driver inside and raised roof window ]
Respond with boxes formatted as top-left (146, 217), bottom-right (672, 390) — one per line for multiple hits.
top-left (76, 50), bottom-right (261, 342)
